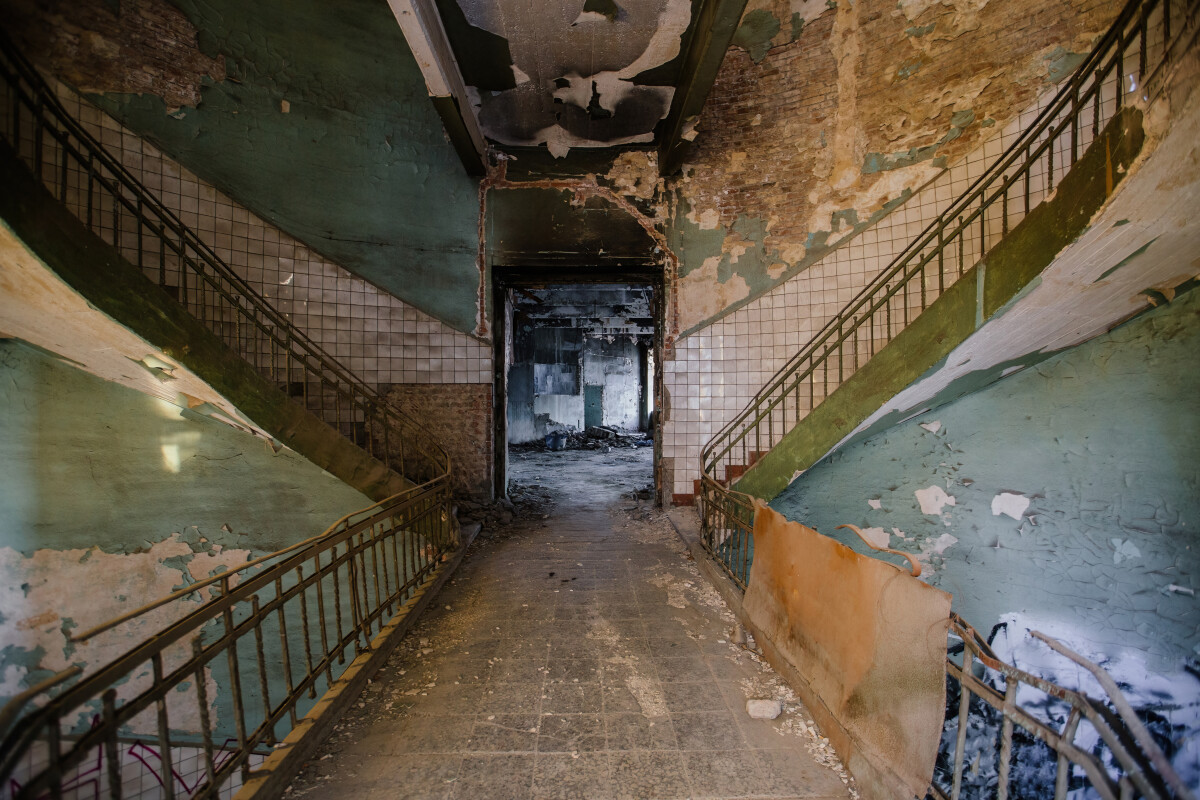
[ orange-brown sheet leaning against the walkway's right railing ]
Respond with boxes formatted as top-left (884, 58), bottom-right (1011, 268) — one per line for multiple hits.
top-left (744, 504), bottom-right (950, 796)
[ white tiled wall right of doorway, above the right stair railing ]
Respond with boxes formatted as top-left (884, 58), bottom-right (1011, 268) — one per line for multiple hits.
top-left (662, 84), bottom-right (1091, 494)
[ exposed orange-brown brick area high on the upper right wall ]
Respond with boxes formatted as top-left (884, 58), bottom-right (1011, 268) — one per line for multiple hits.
top-left (674, 0), bottom-right (1122, 267)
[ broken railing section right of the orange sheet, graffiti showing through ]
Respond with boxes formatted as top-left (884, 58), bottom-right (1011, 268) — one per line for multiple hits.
top-left (929, 615), bottom-right (1194, 800)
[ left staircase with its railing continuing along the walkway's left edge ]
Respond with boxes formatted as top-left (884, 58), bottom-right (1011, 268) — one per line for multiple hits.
top-left (0, 26), bottom-right (463, 799)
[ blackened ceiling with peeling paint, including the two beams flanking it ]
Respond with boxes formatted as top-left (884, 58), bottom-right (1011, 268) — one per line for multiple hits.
top-left (389, 0), bottom-right (746, 174)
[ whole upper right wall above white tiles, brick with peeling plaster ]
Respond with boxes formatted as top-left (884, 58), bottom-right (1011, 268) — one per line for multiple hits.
top-left (666, 0), bottom-right (1121, 335)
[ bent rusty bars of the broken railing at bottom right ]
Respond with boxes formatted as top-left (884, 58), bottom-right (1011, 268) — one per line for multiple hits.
top-left (929, 613), bottom-right (1194, 800)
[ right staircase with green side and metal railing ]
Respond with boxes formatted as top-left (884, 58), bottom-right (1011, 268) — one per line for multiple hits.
top-left (697, 0), bottom-right (1200, 590)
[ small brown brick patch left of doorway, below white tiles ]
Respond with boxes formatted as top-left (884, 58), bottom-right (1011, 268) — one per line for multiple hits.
top-left (384, 384), bottom-right (492, 498)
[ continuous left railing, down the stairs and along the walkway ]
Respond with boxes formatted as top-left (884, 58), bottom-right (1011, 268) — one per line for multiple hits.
top-left (0, 26), bottom-right (457, 800)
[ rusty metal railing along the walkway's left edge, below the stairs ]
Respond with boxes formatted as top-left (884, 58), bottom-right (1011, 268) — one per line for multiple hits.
top-left (0, 479), bottom-right (456, 800)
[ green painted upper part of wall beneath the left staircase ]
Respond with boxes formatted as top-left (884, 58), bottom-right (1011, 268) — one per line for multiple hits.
top-left (0, 341), bottom-right (371, 556)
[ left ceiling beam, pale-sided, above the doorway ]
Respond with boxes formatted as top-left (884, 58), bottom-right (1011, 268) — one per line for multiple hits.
top-left (388, 0), bottom-right (487, 175)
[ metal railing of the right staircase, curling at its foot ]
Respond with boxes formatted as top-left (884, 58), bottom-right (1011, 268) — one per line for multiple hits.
top-left (698, 0), bottom-right (1200, 589)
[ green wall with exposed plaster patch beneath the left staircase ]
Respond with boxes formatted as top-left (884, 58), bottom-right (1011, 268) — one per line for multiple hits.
top-left (0, 339), bottom-right (371, 714)
